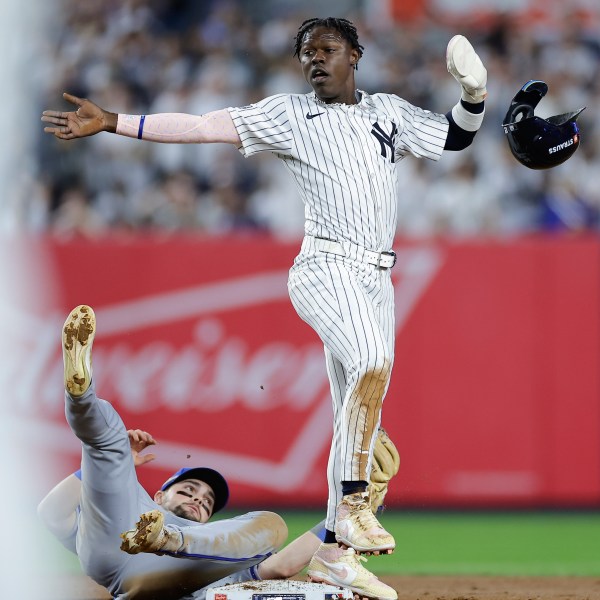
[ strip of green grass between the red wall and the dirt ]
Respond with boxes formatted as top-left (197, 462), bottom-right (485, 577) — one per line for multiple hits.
top-left (42, 510), bottom-right (600, 577)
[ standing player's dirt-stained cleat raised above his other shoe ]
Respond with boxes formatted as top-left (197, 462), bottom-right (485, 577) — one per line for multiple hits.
top-left (335, 492), bottom-right (396, 554)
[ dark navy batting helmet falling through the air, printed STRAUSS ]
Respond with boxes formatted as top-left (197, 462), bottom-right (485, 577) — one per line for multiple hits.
top-left (502, 79), bottom-right (585, 169)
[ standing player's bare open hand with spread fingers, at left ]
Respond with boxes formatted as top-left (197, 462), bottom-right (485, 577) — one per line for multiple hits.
top-left (42, 93), bottom-right (117, 140)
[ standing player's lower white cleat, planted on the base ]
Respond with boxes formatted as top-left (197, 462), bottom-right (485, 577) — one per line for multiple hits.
top-left (308, 544), bottom-right (398, 600)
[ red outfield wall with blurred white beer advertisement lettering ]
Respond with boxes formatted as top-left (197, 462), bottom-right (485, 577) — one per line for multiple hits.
top-left (10, 237), bottom-right (600, 508)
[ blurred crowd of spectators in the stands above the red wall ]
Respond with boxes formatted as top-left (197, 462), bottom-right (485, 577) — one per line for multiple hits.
top-left (11, 0), bottom-right (600, 238)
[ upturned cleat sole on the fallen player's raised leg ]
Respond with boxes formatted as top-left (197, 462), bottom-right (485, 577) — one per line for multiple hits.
top-left (62, 304), bottom-right (96, 397)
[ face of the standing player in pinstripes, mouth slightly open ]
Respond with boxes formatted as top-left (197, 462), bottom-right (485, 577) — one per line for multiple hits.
top-left (300, 26), bottom-right (359, 104)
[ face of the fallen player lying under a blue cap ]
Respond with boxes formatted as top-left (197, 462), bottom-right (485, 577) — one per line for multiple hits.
top-left (155, 479), bottom-right (215, 523)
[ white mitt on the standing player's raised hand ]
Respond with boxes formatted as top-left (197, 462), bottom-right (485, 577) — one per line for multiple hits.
top-left (446, 35), bottom-right (487, 104)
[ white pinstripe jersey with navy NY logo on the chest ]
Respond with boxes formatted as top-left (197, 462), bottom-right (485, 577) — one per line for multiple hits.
top-left (228, 91), bottom-right (448, 251)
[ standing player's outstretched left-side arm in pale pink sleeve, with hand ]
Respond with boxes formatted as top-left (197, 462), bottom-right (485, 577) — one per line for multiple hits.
top-left (42, 93), bottom-right (241, 146)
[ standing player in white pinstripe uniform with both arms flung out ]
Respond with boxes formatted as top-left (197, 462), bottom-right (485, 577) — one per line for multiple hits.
top-left (42, 17), bottom-right (487, 600)
